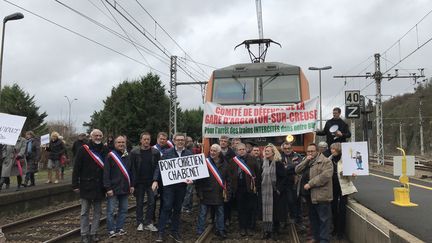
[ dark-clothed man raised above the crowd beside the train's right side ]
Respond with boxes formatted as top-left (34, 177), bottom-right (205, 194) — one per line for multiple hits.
top-left (316, 107), bottom-right (351, 147)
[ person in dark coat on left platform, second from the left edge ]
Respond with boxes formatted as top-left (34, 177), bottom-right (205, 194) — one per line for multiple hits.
top-left (23, 131), bottom-right (41, 187)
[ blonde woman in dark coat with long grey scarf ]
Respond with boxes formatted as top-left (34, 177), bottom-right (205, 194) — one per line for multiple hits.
top-left (261, 144), bottom-right (287, 240)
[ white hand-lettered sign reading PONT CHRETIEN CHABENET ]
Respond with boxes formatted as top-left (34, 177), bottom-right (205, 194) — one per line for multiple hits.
top-left (158, 154), bottom-right (209, 186)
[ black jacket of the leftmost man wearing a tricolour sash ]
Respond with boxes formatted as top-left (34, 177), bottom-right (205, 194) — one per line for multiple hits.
top-left (72, 142), bottom-right (108, 200)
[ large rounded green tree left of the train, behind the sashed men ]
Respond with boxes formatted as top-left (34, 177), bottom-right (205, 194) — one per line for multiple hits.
top-left (84, 73), bottom-right (169, 144)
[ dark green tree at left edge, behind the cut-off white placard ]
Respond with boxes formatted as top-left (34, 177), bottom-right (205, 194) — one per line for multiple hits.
top-left (0, 84), bottom-right (48, 135)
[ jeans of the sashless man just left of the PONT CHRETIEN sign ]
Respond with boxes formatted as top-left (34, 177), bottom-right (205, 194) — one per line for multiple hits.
top-left (135, 184), bottom-right (155, 225)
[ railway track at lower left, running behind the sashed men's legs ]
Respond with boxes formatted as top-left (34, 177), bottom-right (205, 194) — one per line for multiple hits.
top-left (0, 201), bottom-right (135, 243)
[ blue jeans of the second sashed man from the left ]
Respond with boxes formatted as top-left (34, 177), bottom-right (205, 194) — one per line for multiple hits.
top-left (107, 194), bottom-right (128, 232)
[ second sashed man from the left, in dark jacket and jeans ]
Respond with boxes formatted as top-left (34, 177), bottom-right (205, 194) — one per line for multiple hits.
top-left (103, 136), bottom-right (135, 238)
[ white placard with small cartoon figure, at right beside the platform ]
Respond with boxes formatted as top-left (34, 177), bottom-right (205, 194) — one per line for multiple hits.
top-left (342, 142), bottom-right (369, 176)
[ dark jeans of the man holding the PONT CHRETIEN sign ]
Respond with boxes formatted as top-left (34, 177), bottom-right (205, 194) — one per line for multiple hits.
top-left (158, 183), bottom-right (186, 235)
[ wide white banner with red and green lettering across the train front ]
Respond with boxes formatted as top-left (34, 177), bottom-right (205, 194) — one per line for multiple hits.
top-left (202, 98), bottom-right (318, 138)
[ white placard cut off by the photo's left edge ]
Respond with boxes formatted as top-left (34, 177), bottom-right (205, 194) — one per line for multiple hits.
top-left (0, 113), bottom-right (27, 145)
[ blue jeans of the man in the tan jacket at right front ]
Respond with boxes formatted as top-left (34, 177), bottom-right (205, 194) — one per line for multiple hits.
top-left (309, 202), bottom-right (332, 243)
